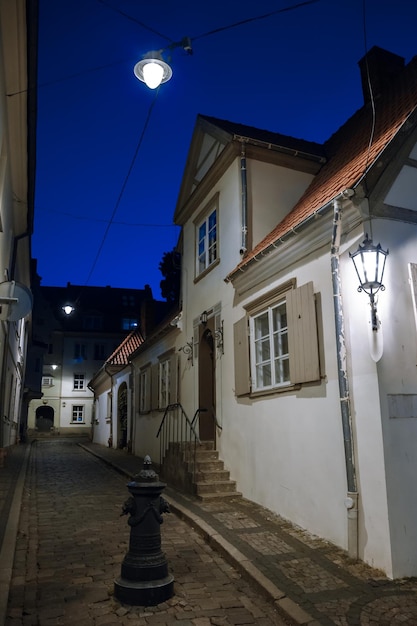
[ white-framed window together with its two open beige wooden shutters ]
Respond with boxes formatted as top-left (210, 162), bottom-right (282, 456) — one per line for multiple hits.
top-left (233, 281), bottom-right (321, 396)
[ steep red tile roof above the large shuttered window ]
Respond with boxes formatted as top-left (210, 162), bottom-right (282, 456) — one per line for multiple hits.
top-left (228, 50), bottom-right (417, 279)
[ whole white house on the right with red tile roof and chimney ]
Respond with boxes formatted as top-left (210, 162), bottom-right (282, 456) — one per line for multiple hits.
top-left (90, 48), bottom-right (417, 578)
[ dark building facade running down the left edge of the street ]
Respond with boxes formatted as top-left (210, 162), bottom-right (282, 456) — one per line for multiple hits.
top-left (0, 0), bottom-right (40, 450)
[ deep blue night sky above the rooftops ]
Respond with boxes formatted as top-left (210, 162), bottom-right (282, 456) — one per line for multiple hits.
top-left (32, 0), bottom-right (417, 298)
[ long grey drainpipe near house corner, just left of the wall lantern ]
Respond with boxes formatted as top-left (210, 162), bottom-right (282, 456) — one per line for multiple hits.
top-left (330, 198), bottom-right (358, 559)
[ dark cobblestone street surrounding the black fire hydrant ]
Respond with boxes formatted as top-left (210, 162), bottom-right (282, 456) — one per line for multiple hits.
top-left (6, 440), bottom-right (289, 626)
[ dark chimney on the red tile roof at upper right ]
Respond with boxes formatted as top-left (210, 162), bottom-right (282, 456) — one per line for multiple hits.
top-left (358, 46), bottom-right (404, 104)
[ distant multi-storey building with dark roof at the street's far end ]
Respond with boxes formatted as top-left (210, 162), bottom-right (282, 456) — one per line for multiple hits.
top-left (28, 284), bottom-right (166, 436)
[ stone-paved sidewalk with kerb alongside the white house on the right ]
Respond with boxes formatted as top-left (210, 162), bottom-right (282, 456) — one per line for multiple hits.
top-left (81, 444), bottom-right (417, 626)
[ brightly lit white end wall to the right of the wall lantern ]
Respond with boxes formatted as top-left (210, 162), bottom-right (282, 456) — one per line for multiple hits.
top-left (359, 220), bottom-right (417, 578)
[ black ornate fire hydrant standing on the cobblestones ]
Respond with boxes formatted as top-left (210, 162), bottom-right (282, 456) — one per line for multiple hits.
top-left (114, 456), bottom-right (174, 606)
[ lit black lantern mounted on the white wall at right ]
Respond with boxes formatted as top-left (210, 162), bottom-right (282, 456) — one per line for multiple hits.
top-left (349, 234), bottom-right (389, 330)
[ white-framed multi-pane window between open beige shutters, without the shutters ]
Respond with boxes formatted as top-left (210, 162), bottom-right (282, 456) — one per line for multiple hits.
top-left (250, 300), bottom-right (290, 391)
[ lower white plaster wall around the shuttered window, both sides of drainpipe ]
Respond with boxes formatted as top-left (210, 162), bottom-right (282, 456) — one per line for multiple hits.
top-left (219, 227), bottom-right (391, 572)
